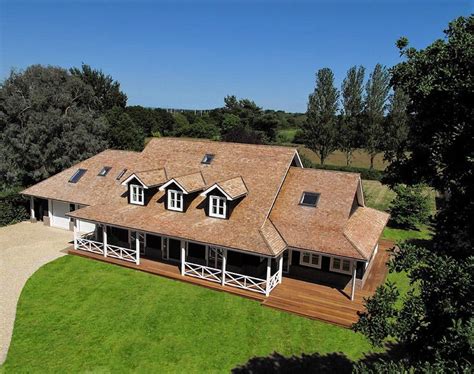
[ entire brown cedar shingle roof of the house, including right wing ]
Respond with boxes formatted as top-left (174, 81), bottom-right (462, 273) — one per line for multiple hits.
top-left (23, 138), bottom-right (387, 259)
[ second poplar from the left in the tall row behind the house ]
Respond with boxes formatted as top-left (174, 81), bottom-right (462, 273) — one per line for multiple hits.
top-left (338, 66), bottom-right (365, 166)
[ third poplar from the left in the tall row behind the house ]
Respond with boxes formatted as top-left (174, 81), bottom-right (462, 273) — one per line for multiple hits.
top-left (362, 64), bottom-right (390, 169)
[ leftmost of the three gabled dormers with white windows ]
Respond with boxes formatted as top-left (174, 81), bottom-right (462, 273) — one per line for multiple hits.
top-left (122, 169), bottom-right (167, 205)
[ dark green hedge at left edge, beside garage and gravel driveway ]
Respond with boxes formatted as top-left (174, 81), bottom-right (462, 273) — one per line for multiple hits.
top-left (0, 188), bottom-right (29, 226)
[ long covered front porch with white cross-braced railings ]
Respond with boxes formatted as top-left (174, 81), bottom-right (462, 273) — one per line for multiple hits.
top-left (74, 224), bottom-right (283, 296)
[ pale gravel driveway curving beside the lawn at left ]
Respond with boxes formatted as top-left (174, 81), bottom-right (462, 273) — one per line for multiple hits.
top-left (0, 222), bottom-right (73, 365)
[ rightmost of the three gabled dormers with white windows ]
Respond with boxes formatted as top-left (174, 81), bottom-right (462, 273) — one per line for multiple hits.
top-left (201, 177), bottom-right (248, 219)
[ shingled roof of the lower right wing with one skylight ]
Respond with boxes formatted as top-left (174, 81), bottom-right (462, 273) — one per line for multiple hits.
top-left (270, 167), bottom-right (388, 260)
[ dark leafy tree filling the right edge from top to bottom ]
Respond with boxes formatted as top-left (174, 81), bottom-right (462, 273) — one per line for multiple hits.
top-left (356, 16), bottom-right (474, 372)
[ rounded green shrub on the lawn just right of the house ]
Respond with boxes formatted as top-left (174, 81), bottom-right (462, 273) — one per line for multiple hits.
top-left (390, 184), bottom-right (430, 229)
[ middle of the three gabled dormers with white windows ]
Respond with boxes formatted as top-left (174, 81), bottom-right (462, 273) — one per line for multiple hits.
top-left (160, 172), bottom-right (206, 212)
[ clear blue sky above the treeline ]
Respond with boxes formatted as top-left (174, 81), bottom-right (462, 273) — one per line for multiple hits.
top-left (0, 0), bottom-right (473, 111)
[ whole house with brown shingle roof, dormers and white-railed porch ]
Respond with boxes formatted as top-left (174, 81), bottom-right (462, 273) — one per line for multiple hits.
top-left (22, 138), bottom-right (388, 298)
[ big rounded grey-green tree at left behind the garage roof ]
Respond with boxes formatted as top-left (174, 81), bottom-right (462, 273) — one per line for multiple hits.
top-left (0, 65), bottom-right (107, 187)
